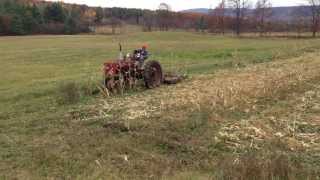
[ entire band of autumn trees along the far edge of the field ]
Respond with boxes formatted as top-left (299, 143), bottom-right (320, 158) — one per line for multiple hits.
top-left (0, 0), bottom-right (320, 37)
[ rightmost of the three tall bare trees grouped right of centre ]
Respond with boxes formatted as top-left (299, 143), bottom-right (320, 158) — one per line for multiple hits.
top-left (254, 0), bottom-right (272, 36)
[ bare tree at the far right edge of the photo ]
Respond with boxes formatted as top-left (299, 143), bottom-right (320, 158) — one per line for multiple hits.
top-left (307, 0), bottom-right (320, 37)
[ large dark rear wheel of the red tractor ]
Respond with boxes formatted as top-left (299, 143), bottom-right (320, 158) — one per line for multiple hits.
top-left (144, 61), bottom-right (163, 89)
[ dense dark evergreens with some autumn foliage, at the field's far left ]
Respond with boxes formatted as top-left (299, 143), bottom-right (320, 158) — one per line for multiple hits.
top-left (0, 0), bottom-right (89, 35)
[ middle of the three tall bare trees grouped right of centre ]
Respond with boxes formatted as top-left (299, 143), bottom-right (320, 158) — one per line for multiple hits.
top-left (228, 0), bottom-right (250, 36)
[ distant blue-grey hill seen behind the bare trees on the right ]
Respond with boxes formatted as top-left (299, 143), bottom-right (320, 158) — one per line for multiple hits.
top-left (182, 6), bottom-right (311, 21)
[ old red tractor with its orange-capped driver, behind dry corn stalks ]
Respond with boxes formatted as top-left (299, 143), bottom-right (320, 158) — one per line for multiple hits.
top-left (103, 45), bottom-right (164, 93)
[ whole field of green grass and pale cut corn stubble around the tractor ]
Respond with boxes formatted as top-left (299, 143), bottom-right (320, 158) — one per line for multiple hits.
top-left (0, 32), bottom-right (320, 179)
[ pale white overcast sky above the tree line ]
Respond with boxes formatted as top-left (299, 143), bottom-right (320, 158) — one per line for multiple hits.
top-left (50, 0), bottom-right (306, 11)
